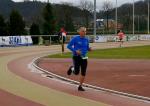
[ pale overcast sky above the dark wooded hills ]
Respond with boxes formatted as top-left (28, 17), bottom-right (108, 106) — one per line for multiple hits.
top-left (13, 0), bottom-right (140, 9)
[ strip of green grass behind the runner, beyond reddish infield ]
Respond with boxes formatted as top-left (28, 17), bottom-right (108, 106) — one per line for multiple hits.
top-left (48, 46), bottom-right (150, 59)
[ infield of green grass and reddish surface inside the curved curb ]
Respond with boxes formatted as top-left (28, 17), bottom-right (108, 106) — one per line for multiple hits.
top-left (38, 46), bottom-right (150, 97)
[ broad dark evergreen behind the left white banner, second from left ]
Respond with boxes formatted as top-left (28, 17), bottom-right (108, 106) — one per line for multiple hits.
top-left (9, 10), bottom-right (25, 35)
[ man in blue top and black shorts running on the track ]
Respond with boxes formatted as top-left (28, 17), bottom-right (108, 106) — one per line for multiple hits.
top-left (67, 27), bottom-right (91, 91)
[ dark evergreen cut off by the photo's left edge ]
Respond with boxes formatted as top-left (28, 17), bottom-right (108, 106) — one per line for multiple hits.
top-left (0, 15), bottom-right (7, 36)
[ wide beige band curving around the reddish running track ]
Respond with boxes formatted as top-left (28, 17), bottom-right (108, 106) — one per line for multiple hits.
top-left (0, 46), bottom-right (107, 106)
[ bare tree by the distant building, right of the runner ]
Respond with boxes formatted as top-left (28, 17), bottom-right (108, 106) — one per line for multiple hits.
top-left (103, 0), bottom-right (113, 30)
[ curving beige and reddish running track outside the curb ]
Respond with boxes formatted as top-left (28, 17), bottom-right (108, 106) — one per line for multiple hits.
top-left (0, 42), bottom-right (150, 106)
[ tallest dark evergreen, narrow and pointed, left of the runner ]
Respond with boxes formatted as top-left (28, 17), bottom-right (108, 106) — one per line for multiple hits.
top-left (43, 3), bottom-right (56, 35)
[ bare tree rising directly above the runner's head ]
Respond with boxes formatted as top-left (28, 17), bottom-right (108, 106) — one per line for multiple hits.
top-left (80, 0), bottom-right (94, 27)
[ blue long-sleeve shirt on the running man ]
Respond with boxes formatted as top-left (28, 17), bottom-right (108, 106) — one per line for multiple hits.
top-left (67, 35), bottom-right (89, 57)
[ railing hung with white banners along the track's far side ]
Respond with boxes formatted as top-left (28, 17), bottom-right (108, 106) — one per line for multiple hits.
top-left (0, 34), bottom-right (150, 46)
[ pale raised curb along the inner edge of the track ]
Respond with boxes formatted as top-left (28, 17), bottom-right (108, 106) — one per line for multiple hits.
top-left (30, 56), bottom-right (150, 102)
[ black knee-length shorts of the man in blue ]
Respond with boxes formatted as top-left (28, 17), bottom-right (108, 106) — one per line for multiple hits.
top-left (73, 56), bottom-right (88, 76)
